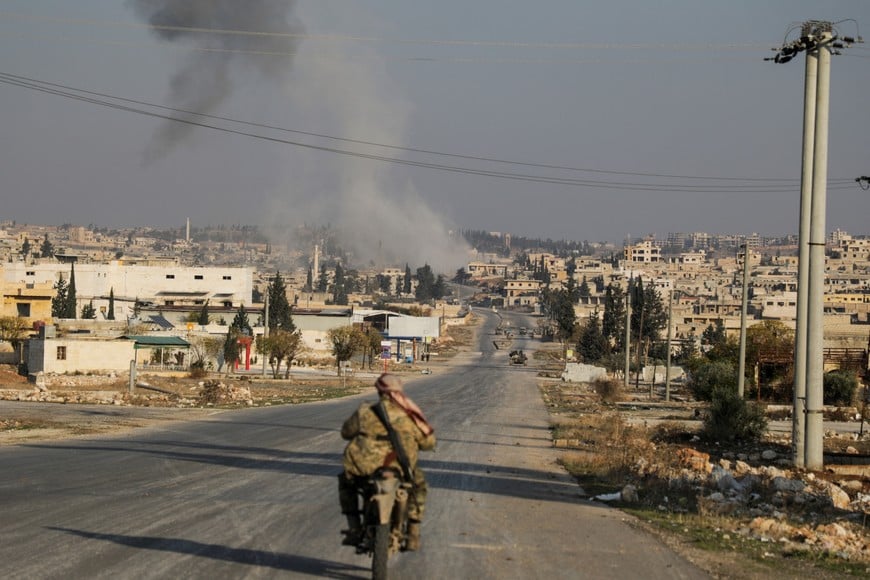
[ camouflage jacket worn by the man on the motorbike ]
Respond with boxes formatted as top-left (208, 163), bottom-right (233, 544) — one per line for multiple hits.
top-left (341, 398), bottom-right (435, 475)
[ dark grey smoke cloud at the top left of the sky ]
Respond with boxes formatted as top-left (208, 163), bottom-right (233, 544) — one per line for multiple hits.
top-left (128, 0), bottom-right (303, 157)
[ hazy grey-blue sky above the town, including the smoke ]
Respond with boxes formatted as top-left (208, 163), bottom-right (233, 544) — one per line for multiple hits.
top-left (0, 0), bottom-right (870, 263)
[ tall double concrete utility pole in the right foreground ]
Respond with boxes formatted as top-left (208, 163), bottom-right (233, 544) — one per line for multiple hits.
top-left (765, 20), bottom-right (863, 469)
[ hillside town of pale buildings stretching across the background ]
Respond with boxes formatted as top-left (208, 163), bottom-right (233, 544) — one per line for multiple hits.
top-left (0, 220), bottom-right (870, 375)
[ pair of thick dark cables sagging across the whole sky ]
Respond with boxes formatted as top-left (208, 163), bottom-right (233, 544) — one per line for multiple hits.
top-left (0, 72), bottom-right (851, 193)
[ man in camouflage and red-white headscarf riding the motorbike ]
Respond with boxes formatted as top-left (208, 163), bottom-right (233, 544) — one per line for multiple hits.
top-left (338, 373), bottom-right (435, 550)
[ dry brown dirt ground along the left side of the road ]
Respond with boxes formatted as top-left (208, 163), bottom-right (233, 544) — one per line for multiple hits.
top-left (0, 365), bottom-right (372, 446)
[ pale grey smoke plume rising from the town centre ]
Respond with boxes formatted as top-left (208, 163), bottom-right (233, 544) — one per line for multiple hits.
top-left (264, 6), bottom-right (469, 276)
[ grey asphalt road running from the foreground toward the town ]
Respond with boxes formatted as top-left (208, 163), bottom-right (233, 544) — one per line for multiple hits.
top-left (0, 312), bottom-right (708, 580)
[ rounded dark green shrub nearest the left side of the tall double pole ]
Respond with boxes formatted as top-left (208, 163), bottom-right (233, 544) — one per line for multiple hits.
top-left (701, 388), bottom-right (767, 443)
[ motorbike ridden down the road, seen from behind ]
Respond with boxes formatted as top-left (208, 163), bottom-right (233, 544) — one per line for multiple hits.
top-left (356, 468), bottom-right (413, 580)
